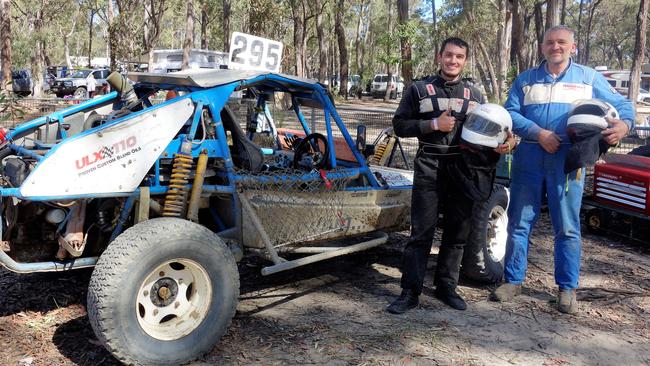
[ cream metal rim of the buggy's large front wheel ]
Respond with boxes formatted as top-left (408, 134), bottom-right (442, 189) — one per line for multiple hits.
top-left (135, 258), bottom-right (212, 341)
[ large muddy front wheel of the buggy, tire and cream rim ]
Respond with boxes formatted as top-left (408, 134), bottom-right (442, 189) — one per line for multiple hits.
top-left (87, 218), bottom-right (239, 365)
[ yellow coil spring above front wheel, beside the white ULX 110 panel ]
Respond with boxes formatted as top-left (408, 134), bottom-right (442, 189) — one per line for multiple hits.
top-left (163, 153), bottom-right (192, 217)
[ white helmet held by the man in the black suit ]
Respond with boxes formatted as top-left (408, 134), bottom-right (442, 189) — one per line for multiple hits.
top-left (460, 103), bottom-right (512, 149)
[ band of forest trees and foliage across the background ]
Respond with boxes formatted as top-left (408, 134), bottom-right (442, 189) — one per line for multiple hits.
top-left (0, 0), bottom-right (648, 100)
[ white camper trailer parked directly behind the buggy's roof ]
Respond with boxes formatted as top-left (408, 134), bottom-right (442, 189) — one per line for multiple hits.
top-left (149, 48), bottom-right (228, 73)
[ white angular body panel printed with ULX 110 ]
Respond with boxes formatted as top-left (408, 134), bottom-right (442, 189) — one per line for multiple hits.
top-left (20, 99), bottom-right (194, 197)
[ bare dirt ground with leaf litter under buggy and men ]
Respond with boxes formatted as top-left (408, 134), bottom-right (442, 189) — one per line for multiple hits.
top-left (0, 215), bottom-right (650, 366)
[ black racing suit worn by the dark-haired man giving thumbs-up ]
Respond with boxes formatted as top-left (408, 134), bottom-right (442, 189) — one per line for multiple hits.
top-left (393, 76), bottom-right (484, 295)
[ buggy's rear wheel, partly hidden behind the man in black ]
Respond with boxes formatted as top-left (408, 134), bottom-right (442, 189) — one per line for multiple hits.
top-left (462, 184), bottom-right (508, 283)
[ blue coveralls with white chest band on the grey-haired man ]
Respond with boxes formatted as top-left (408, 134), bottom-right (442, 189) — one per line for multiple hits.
top-left (504, 61), bottom-right (634, 289)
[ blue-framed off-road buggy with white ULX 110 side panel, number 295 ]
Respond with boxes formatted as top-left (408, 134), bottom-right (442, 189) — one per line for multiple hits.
top-left (0, 70), bottom-right (507, 364)
